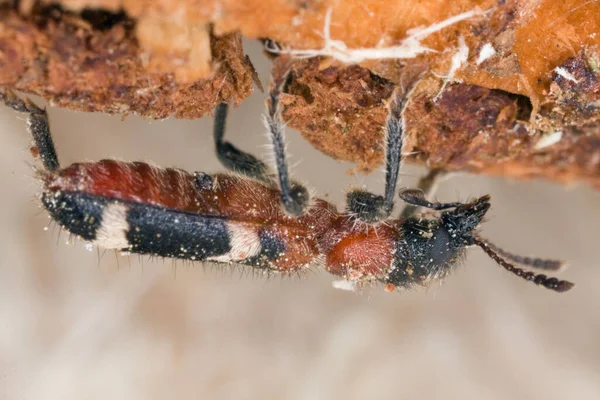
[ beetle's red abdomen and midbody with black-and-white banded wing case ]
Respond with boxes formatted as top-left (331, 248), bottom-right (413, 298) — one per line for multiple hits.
top-left (42, 160), bottom-right (329, 272)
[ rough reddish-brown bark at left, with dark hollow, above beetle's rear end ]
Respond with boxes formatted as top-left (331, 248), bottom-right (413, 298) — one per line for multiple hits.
top-left (0, 8), bottom-right (253, 118)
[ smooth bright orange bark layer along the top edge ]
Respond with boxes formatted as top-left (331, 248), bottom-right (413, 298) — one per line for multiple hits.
top-left (21, 0), bottom-right (600, 109)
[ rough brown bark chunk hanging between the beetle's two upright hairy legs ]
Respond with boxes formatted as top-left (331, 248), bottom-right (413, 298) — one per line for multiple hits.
top-left (278, 58), bottom-right (394, 171)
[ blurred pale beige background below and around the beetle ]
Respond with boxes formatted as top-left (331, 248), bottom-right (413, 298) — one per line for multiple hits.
top-left (0, 43), bottom-right (600, 400)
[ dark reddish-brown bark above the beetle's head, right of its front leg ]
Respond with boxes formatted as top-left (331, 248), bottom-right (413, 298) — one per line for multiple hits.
top-left (406, 74), bottom-right (600, 187)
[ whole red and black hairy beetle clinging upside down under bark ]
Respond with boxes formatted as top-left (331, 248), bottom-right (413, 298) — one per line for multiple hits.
top-left (0, 71), bottom-right (573, 292)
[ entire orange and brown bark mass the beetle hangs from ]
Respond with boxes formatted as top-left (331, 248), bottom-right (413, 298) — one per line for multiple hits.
top-left (0, 0), bottom-right (600, 187)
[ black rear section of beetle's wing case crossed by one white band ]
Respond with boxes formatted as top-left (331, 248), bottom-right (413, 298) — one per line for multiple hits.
top-left (42, 191), bottom-right (234, 260)
